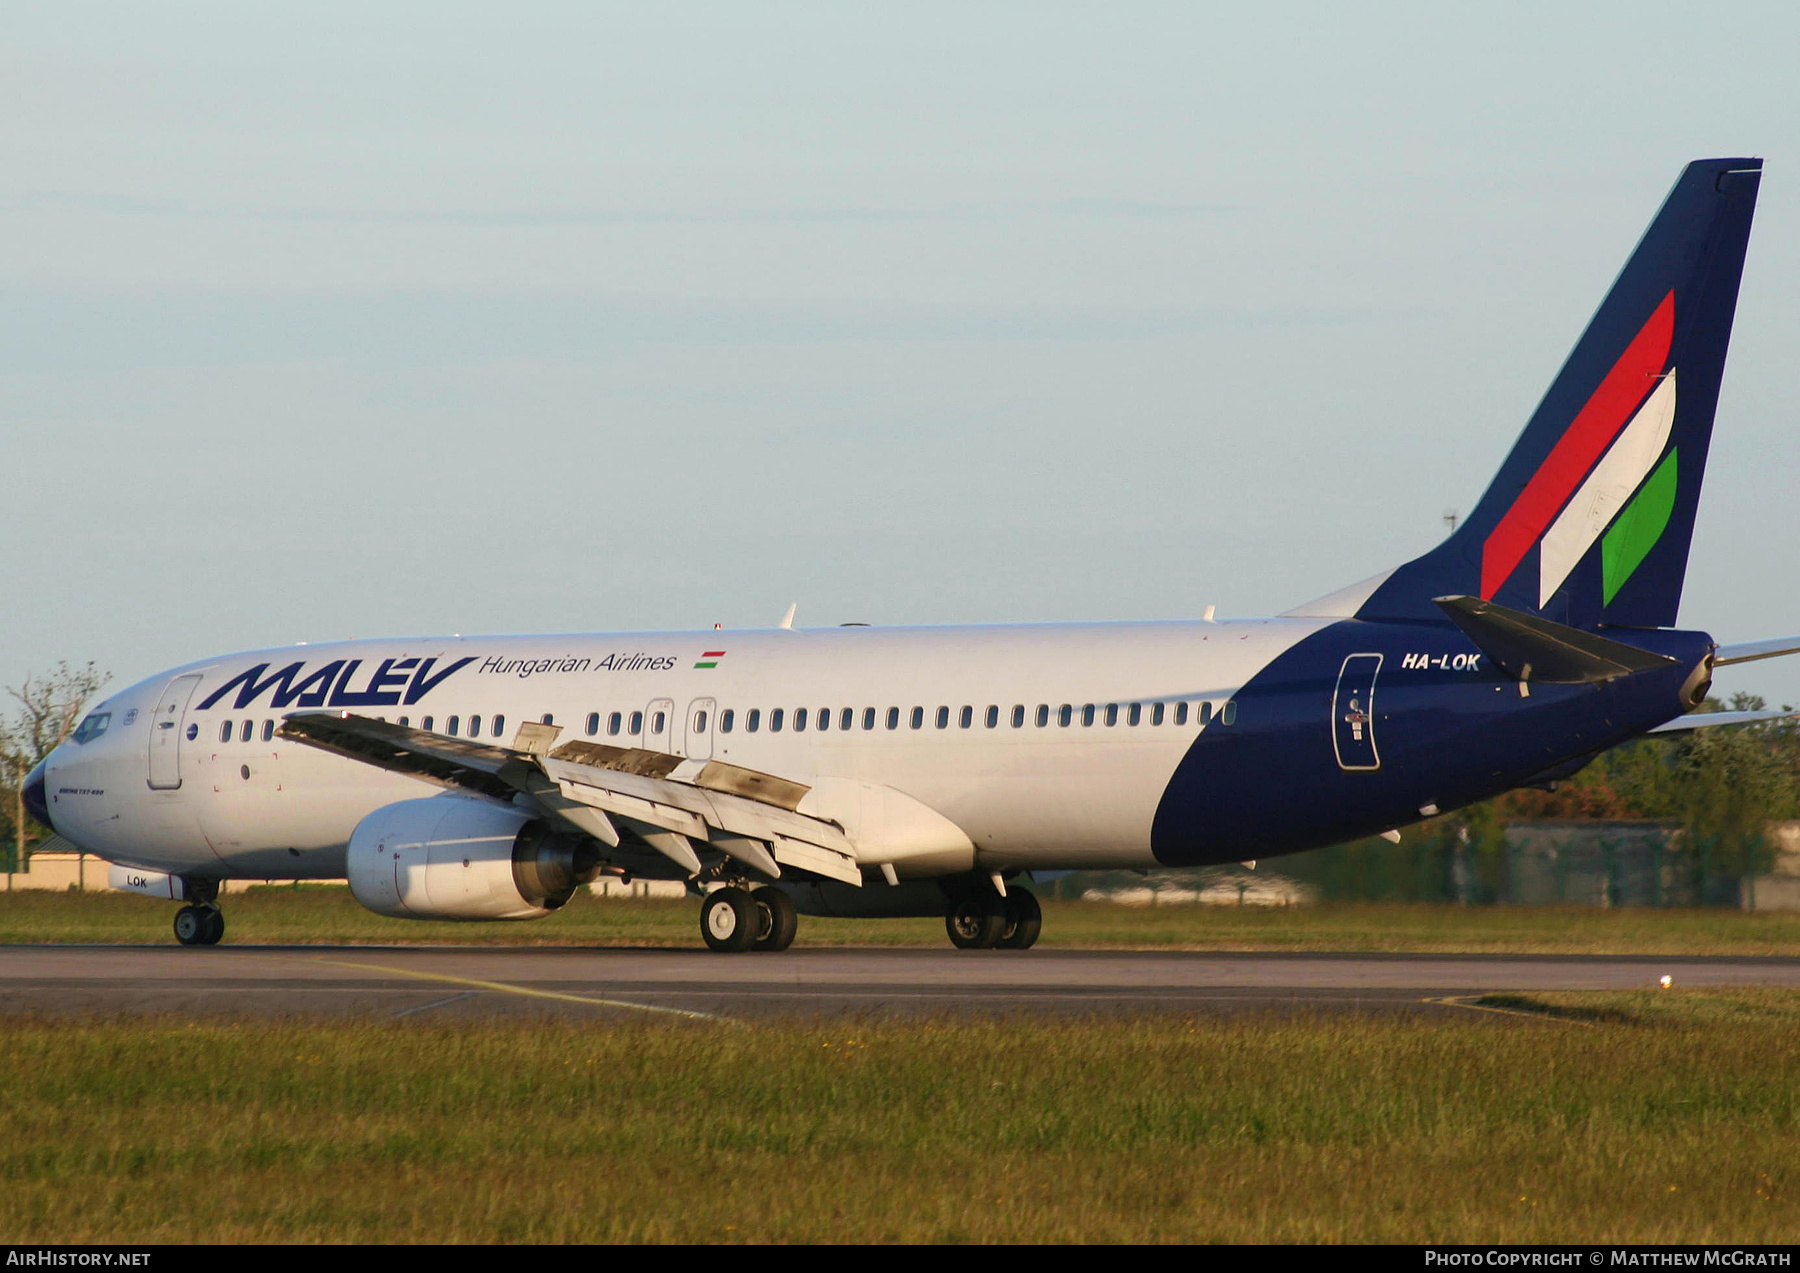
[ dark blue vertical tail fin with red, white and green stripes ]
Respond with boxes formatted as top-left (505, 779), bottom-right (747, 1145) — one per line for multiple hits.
top-left (1357, 158), bottom-right (1762, 628)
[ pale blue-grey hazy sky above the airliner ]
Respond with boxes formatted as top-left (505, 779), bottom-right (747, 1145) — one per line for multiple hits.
top-left (0, 0), bottom-right (1800, 704)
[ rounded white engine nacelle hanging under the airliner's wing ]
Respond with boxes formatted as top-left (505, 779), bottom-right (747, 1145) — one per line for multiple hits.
top-left (346, 796), bottom-right (599, 920)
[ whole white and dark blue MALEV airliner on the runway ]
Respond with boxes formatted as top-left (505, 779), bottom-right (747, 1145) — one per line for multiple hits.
top-left (17, 158), bottom-right (1800, 951)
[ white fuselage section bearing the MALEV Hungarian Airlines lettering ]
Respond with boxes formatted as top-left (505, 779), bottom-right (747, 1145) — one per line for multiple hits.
top-left (45, 618), bottom-right (1330, 879)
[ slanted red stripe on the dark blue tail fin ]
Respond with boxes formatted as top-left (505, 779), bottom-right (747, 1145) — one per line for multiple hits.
top-left (1481, 292), bottom-right (1676, 600)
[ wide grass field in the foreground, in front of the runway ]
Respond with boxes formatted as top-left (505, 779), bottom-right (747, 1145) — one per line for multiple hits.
top-left (0, 990), bottom-right (1800, 1244)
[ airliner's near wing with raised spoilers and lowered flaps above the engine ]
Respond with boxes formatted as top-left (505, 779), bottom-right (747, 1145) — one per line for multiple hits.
top-left (281, 711), bottom-right (862, 884)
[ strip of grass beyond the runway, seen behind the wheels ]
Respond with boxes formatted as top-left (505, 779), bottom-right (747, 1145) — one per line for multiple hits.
top-left (0, 886), bottom-right (1800, 954)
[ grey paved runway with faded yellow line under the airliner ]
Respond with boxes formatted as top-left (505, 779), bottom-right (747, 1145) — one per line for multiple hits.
top-left (0, 945), bottom-right (1800, 1021)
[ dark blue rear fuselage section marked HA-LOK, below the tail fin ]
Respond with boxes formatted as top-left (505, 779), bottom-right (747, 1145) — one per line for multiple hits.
top-left (1150, 619), bottom-right (1714, 866)
